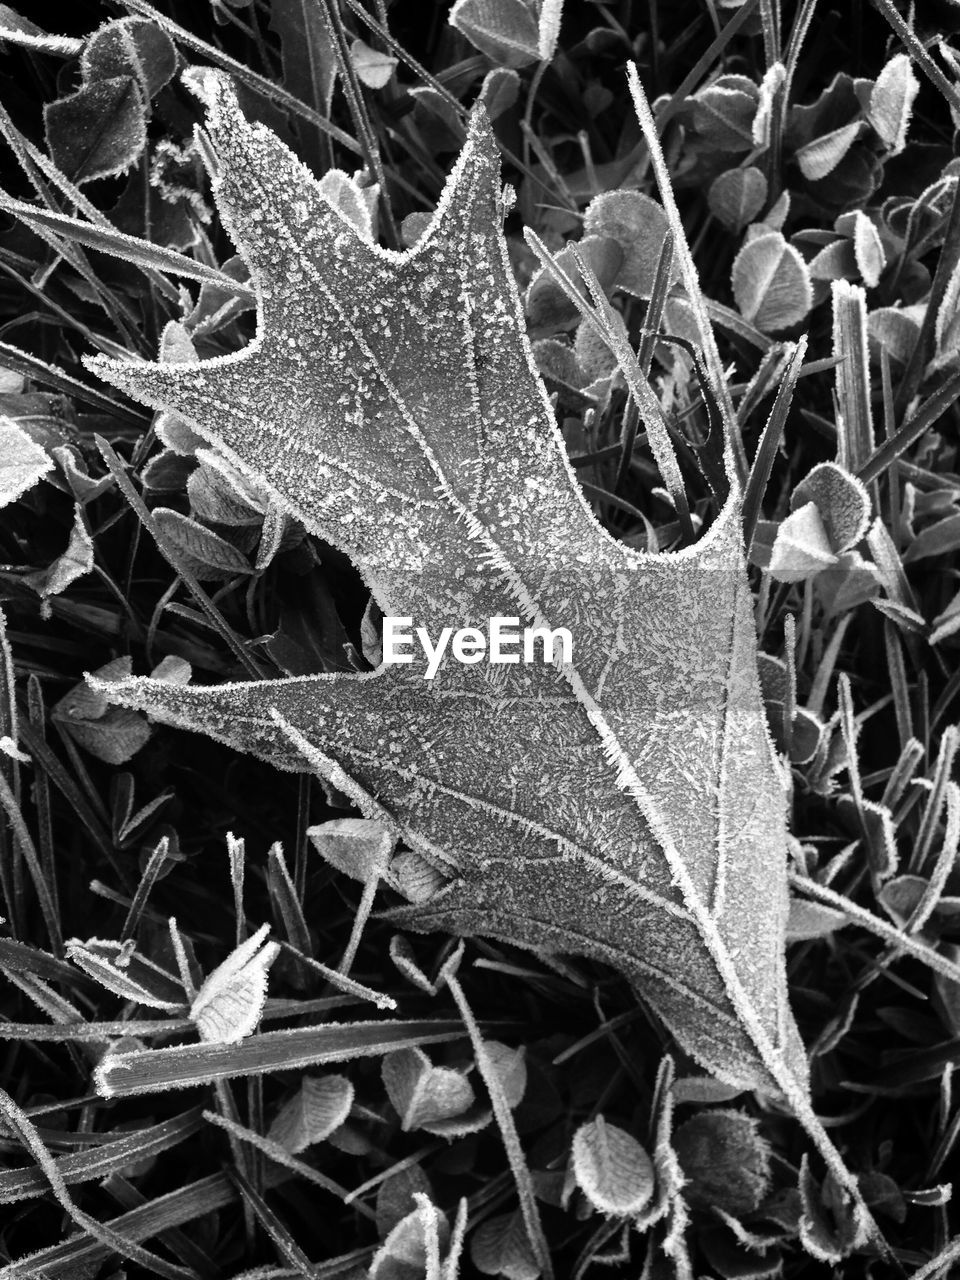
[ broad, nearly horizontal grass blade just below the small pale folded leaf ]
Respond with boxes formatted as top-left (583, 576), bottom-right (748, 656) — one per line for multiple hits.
top-left (95, 1019), bottom-right (463, 1097)
